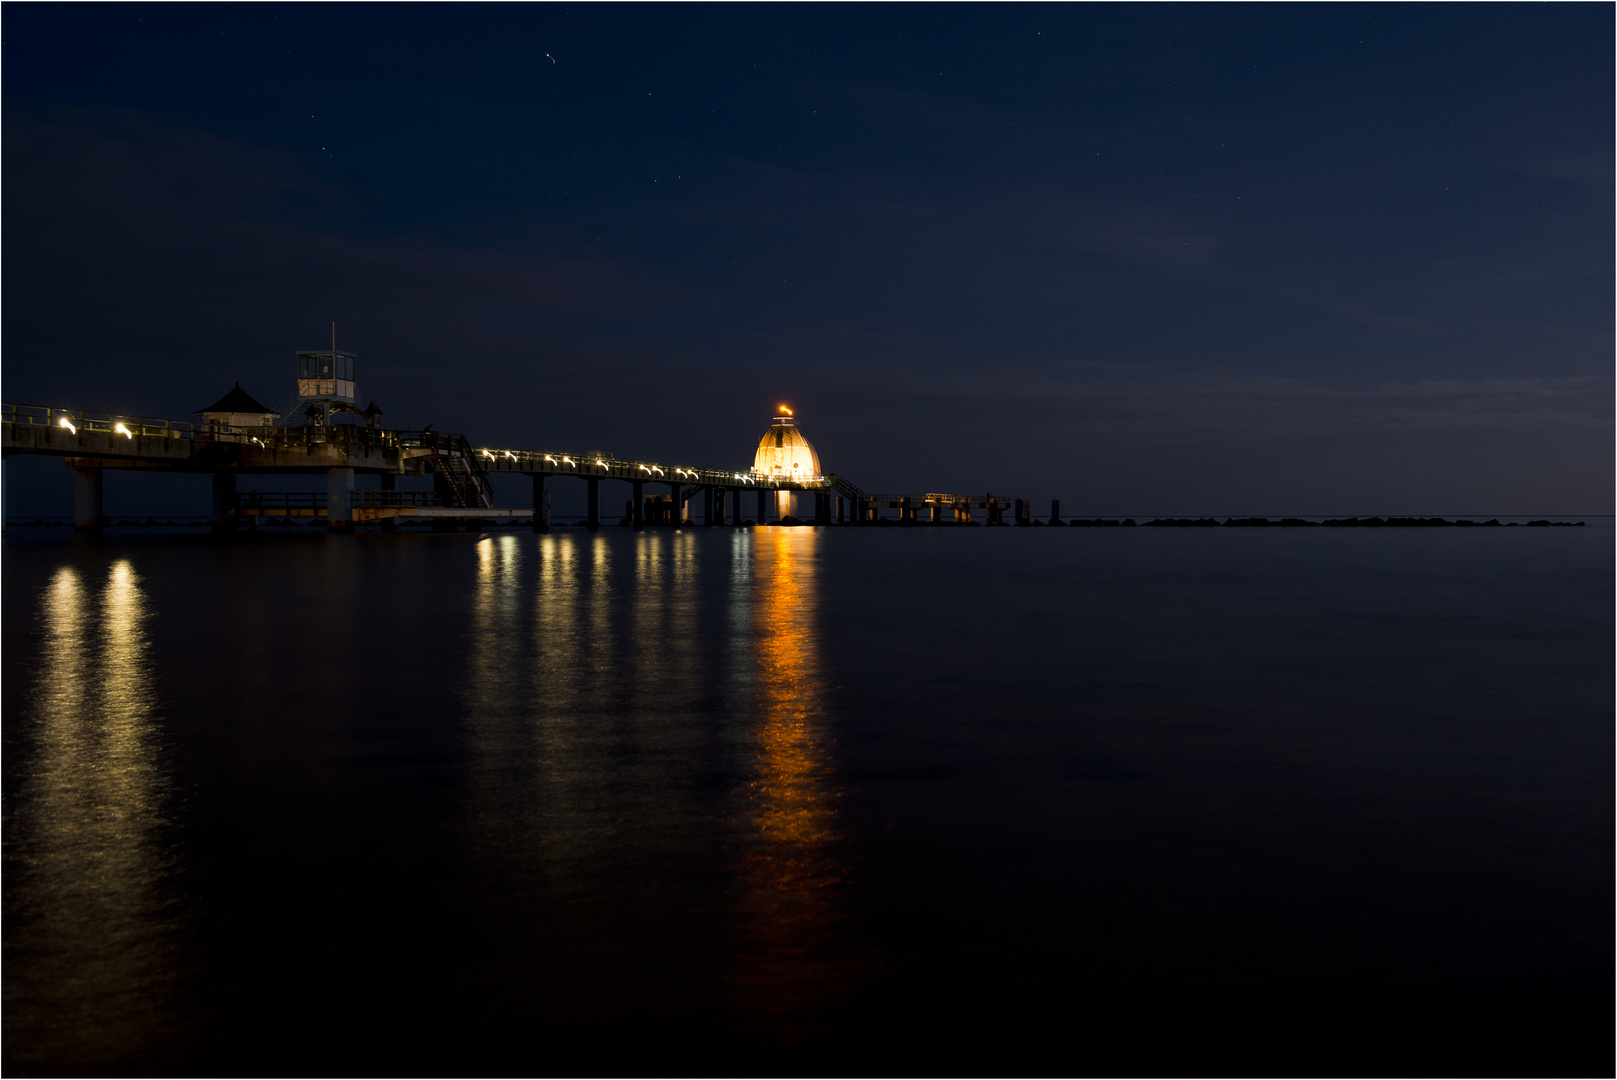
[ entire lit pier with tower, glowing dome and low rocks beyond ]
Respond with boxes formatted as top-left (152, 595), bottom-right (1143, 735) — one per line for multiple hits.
top-left (9, 355), bottom-right (1581, 534)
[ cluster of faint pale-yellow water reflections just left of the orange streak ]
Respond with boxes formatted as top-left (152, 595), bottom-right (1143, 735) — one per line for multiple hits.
top-left (466, 532), bottom-right (710, 1017)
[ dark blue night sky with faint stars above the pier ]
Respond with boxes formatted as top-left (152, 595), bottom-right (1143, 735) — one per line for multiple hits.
top-left (3, 5), bottom-right (1614, 517)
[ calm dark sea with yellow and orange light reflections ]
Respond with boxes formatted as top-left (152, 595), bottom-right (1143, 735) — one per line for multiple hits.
top-left (3, 527), bottom-right (1614, 1075)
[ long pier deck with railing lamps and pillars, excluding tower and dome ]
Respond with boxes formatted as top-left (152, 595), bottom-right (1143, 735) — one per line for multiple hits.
top-left (0, 400), bottom-right (1030, 532)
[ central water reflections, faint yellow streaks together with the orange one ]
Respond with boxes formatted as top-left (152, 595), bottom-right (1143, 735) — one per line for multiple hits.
top-left (464, 529), bottom-right (851, 1043)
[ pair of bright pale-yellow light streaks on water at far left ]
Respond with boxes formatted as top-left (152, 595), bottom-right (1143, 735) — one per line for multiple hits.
top-left (5, 559), bottom-right (179, 1069)
